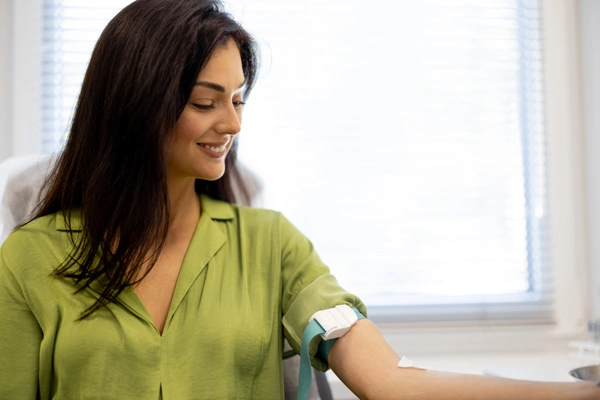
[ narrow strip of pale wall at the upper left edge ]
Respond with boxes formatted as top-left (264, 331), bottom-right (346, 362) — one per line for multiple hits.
top-left (0, 0), bottom-right (13, 162)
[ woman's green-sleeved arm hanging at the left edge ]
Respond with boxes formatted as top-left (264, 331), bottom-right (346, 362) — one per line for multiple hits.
top-left (0, 251), bottom-right (42, 400)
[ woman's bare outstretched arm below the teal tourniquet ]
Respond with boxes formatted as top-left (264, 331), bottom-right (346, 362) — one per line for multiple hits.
top-left (328, 319), bottom-right (600, 400)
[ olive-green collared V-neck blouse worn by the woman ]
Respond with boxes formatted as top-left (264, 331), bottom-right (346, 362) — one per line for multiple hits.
top-left (0, 196), bottom-right (366, 400)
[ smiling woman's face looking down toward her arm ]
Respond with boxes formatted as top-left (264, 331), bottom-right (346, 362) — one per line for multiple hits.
top-left (166, 39), bottom-right (244, 181)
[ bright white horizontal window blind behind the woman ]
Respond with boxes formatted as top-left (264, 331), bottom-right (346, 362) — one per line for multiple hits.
top-left (43, 0), bottom-right (552, 321)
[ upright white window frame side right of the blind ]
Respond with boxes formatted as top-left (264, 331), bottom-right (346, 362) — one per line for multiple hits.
top-left (543, 0), bottom-right (591, 334)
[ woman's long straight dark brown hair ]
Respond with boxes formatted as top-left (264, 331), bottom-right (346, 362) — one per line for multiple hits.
top-left (33, 0), bottom-right (258, 318)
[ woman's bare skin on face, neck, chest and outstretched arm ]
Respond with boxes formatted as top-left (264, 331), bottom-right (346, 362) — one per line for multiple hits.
top-left (135, 40), bottom-right (600, 400)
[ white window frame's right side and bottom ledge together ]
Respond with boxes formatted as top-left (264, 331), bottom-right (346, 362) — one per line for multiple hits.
top-left (378, 0), bottom-right (591, 354)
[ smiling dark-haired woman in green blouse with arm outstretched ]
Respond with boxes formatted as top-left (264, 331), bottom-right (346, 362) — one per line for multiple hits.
top-left (0, 0), bottom-right (600, 400)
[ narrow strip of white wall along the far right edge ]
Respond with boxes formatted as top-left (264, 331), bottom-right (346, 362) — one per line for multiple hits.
top-left (579, 0), bottom-right (600, 318)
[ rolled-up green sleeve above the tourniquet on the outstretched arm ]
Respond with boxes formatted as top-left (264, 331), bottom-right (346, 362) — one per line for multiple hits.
top-left (279, 215), bottom-right (366, 371)
